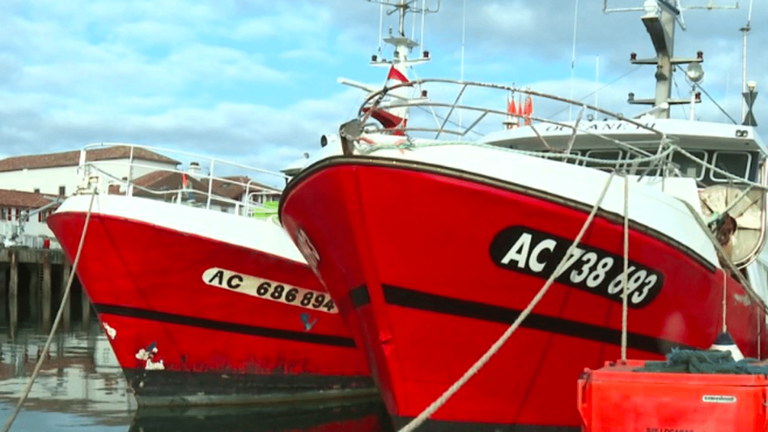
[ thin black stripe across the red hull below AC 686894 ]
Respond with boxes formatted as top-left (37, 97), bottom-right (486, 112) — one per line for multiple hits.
top-left (93, 303), bottom-right (357, 348)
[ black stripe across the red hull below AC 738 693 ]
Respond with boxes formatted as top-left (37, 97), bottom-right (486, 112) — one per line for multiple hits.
top-left (350, 285), bottom-right (695, 354)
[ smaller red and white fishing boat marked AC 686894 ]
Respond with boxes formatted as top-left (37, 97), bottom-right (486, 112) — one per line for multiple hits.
top-left (48, 146), bottom-right (375, 405)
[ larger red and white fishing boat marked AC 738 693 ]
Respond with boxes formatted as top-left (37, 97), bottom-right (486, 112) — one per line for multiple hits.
top-left (280, 2), bottom-right (768, 431)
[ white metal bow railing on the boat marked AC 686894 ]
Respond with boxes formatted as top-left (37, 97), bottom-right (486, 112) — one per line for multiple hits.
top-left (78, 143), bottom-right (287, 218)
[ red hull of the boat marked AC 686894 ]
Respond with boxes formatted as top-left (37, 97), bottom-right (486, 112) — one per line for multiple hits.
top-left (48, 208), bottom-right (374, 405)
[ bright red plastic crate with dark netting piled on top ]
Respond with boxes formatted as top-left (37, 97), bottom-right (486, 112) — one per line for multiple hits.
top-left (578, 360), bottom-right (768, 432)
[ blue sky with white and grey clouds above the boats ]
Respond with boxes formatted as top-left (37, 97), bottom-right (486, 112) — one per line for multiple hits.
top-left (0, 0), bottom-right (768, 175)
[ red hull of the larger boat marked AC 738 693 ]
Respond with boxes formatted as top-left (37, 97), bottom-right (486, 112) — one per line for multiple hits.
top-left (281, 158), bottom-right (766, 430)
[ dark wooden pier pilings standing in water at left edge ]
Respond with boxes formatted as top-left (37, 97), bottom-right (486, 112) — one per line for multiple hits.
top-left (0, 247), bottom-right (92, 336)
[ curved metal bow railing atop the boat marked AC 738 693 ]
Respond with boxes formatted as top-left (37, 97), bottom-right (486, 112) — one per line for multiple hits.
top-left (354, 78), bottom-right (760, 183)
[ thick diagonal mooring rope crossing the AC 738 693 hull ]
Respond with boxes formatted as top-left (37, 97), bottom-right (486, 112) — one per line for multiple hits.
top-left (398, 171), bottom-right (616, 432)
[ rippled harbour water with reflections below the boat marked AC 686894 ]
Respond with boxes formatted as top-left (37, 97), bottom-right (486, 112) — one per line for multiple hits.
top-left (0, 323), bottom-right (391, 432)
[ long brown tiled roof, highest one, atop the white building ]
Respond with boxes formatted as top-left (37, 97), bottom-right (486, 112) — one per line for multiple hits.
top-left (0, 146), bottom-right (181, 172)
